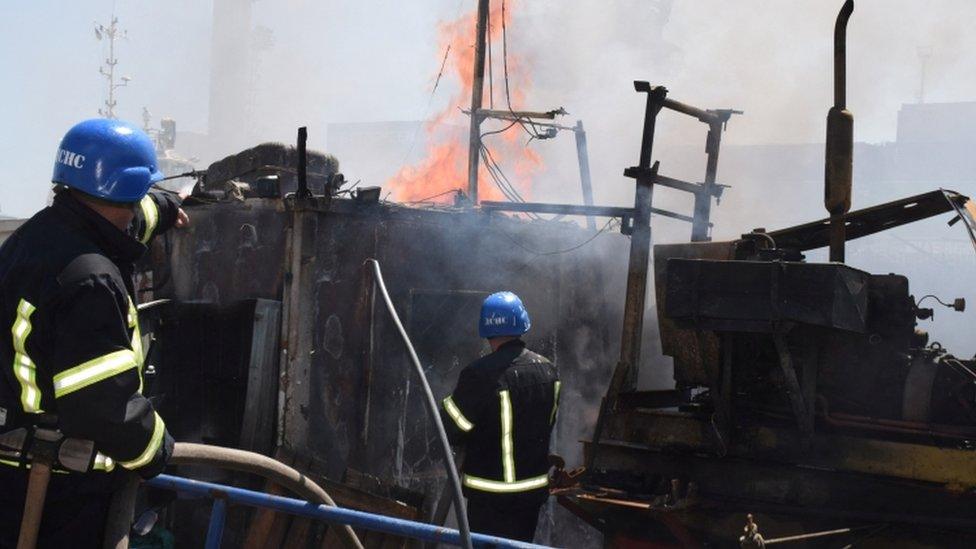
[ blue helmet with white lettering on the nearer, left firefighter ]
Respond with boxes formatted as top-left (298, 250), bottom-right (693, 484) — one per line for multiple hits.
top-left (51, 118), bottom-right (163, 202)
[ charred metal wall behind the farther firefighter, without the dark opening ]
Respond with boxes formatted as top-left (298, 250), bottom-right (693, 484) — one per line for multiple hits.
top-left (155, 195), bottom-right (628, 540)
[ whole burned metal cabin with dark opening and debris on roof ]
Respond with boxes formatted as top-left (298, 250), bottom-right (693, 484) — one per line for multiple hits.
top-left (146, 138), bottom-right (626, 545)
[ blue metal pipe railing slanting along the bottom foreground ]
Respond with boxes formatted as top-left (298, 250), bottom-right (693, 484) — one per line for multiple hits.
top-left (146, 475), bottom-right (545, 549)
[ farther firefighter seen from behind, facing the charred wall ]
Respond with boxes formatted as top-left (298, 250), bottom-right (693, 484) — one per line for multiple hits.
top-left (442, 292), bottom-right (559, 541)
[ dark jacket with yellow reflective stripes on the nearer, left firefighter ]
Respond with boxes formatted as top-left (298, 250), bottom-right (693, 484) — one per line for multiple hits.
top-left (0, 188), bottom-right (179, 475)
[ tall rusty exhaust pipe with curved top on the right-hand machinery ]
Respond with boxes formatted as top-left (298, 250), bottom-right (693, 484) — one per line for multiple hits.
top-left (824, 0), bottom-right (854, 263)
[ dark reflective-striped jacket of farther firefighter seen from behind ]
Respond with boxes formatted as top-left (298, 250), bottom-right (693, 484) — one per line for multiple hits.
top-left (441, 340), bottom-right (559, 494)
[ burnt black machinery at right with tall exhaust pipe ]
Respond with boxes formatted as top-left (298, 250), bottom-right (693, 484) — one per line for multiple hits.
top-left (560, 0), bottom-right (976, 547)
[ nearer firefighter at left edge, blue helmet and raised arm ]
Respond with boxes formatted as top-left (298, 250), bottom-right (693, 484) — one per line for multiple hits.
top-left (0, 119), bottom-right (188, 547)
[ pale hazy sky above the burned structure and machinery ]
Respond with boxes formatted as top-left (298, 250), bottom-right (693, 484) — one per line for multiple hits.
top-left (0, 0), bottom-right (976, 216)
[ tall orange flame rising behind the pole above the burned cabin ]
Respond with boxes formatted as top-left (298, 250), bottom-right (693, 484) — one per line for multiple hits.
top-left (384, 0), bottom-right (542, 202)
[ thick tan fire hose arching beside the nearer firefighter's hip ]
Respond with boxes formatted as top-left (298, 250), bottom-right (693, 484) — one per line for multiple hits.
top-left (106, 442), bottom-right (363, 549)
